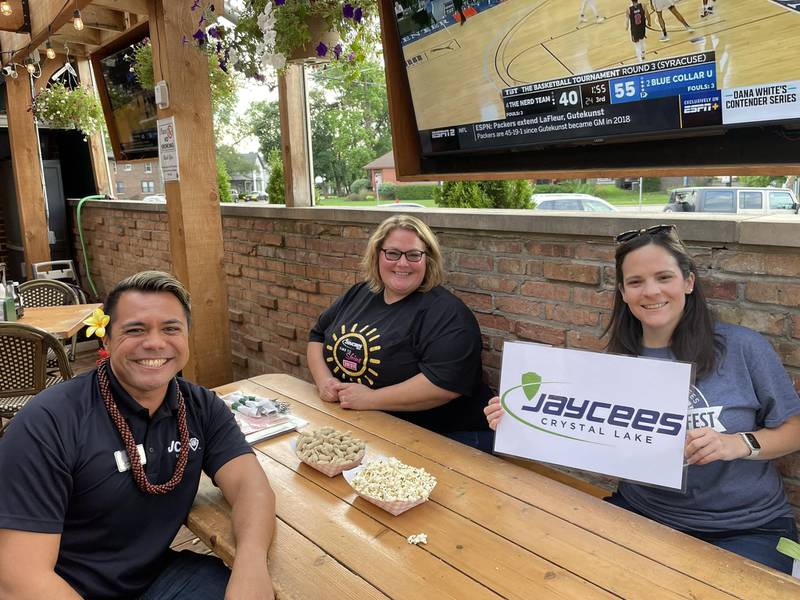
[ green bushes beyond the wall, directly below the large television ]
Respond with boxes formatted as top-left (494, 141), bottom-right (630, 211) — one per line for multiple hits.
top-left (434, 179), bottom-right (531, 208)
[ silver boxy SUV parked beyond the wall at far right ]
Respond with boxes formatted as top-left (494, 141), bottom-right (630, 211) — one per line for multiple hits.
top-left (664, 187), bottom-right (800, 215)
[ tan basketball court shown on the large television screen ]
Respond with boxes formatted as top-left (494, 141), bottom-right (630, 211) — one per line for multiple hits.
top-left (403, 0), bottom-right (800, 130)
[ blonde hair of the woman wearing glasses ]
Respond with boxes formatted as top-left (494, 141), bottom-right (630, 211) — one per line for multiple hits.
top-left (361, 215), bottom-right (444, 294)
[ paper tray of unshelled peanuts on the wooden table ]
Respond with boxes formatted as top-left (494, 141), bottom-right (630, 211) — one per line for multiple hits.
top-left (294, 427), bottom-right (367, 477)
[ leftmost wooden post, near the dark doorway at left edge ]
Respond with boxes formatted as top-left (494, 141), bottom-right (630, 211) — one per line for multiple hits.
top-left (6, 68), bottom-right (50, 278)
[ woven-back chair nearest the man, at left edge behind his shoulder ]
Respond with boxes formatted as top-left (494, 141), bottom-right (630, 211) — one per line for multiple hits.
top-left (0, 321), bottom-right (72, 437)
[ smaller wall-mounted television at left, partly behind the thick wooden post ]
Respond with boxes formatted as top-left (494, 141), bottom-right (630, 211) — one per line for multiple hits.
top-left (92, 23), bottom-right (158, 161)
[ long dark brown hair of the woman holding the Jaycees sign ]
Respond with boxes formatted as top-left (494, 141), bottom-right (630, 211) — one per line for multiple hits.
top-left (604, 228), bottom-right (724, 379)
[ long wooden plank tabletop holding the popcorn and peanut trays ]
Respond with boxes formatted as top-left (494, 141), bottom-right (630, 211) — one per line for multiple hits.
top-left (187, 374), bottom-right (800, 600)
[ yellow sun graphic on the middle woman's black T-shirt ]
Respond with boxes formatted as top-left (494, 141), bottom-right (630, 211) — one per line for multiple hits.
top-left (325, 323), bottom-right (381, 385)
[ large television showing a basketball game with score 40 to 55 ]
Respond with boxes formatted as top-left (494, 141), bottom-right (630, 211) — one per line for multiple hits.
top-left (382, 0), bottom-right (800, 175)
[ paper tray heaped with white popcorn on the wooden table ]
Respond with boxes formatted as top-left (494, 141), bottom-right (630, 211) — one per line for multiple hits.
top-left (343, 456), bottom-right (436, 516)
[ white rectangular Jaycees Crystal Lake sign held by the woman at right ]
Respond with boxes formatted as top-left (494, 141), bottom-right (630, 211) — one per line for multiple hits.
top-left (494, 342), bottom-right (692, 490)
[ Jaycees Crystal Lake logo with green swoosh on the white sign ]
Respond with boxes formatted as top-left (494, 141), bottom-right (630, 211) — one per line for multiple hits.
top-left (500, 373), bottom-right (683, 445)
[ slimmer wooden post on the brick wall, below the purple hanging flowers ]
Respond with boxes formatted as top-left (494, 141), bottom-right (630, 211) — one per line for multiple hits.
top-left (278, 64), bottom-right (314, 206)
